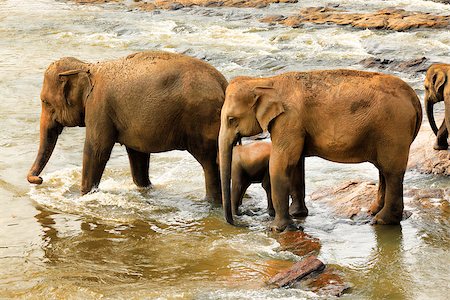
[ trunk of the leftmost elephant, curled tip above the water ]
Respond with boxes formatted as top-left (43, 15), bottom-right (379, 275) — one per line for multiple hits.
top-left (27, 113), bottom-right (63, 184)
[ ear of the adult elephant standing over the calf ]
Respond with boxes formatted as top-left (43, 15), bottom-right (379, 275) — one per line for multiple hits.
top-left (253, 86), bottom-right (285, 131)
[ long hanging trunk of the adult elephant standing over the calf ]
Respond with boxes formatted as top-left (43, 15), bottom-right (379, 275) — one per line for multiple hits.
top-left (219, 126), bottom-right (234, 224)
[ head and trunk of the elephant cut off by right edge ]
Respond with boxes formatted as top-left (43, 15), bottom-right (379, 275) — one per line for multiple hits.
top-left (424, 64), bottom-right (450, 135)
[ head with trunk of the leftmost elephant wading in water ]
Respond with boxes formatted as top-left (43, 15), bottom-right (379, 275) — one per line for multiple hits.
top-left (27, 58), bottom-right (93, 184)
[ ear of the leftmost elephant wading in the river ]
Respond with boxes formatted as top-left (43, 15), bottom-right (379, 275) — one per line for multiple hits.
top-left (58, 69), bottom-right (93, 106)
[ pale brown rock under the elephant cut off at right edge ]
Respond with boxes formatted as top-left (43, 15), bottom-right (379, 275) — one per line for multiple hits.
top-left (408, 120), bottom-right (450, 176)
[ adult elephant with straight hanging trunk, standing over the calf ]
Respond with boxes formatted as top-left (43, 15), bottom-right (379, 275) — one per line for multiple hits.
top-left (219, 70), bottom-right (422, 231)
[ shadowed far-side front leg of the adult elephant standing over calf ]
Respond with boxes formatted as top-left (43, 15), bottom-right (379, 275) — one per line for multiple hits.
top-left (289, 157), bottom-right (308, 218)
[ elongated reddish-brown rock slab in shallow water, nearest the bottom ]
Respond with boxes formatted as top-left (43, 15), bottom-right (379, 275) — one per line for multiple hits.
top-left (267, 256), bottom-right (325, 288)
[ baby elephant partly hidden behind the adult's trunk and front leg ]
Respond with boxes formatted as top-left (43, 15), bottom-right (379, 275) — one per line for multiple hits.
top-left (231, 141), bottom-right (308, 217)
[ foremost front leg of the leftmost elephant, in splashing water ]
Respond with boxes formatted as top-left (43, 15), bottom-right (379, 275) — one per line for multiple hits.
top-left (81, 139), bottom-right (114, 195)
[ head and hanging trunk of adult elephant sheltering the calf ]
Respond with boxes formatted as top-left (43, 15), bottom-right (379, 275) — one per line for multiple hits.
top-left (219, 77), bottom-right (284, 224)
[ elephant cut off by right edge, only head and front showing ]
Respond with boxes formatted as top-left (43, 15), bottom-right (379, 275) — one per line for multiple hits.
top-left (424, 64), bottom-right (450, 150)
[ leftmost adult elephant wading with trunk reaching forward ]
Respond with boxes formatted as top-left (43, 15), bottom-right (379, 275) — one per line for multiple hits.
top-left (28, 51), bottom-right (227, 203)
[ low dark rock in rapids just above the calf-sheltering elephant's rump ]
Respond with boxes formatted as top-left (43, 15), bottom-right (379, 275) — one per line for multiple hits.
top-left (359, 57), bottom-right (433, 73)
